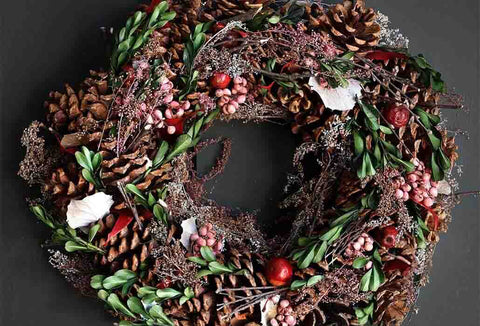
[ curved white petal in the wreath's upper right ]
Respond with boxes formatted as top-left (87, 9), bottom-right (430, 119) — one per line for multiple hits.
top-left (308, 77), bottom-right (362, 111)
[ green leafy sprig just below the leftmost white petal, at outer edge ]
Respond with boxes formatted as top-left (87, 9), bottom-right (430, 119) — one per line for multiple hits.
top-left (30, 205), bottom-right (105, 255)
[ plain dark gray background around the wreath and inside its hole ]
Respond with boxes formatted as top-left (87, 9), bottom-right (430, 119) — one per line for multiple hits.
top-left (0, 0), bottom-right (480, 326)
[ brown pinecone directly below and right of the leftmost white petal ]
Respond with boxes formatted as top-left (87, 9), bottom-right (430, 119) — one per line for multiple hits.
top-left (94, 212), bottom-right (156, 282)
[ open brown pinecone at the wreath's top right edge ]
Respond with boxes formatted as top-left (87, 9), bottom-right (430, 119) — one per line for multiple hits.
top-left (320, 0), bottom-right (380, 51)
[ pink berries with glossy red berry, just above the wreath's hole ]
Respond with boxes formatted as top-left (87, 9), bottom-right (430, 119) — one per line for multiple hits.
top-left (210, 73), bottom-right (248, 114)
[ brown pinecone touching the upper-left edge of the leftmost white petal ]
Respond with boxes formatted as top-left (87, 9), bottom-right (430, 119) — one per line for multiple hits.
top-left (43, 162), bottom-right (95, 213)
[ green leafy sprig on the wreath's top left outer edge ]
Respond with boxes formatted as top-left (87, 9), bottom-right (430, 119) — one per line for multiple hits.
top-left (111, 1), bottom-right (176, 72)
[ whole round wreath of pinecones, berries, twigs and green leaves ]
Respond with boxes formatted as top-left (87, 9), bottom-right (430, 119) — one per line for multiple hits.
top-left (19, 0), bottom-right (468, 326)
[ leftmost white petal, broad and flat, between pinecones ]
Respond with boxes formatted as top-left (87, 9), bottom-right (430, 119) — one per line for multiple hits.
top-left (67, 192), bottom-right (113, 229)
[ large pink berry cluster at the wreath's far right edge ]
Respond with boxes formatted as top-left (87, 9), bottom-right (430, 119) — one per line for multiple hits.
top-left (393, 159), bottom-right (438, 207)
